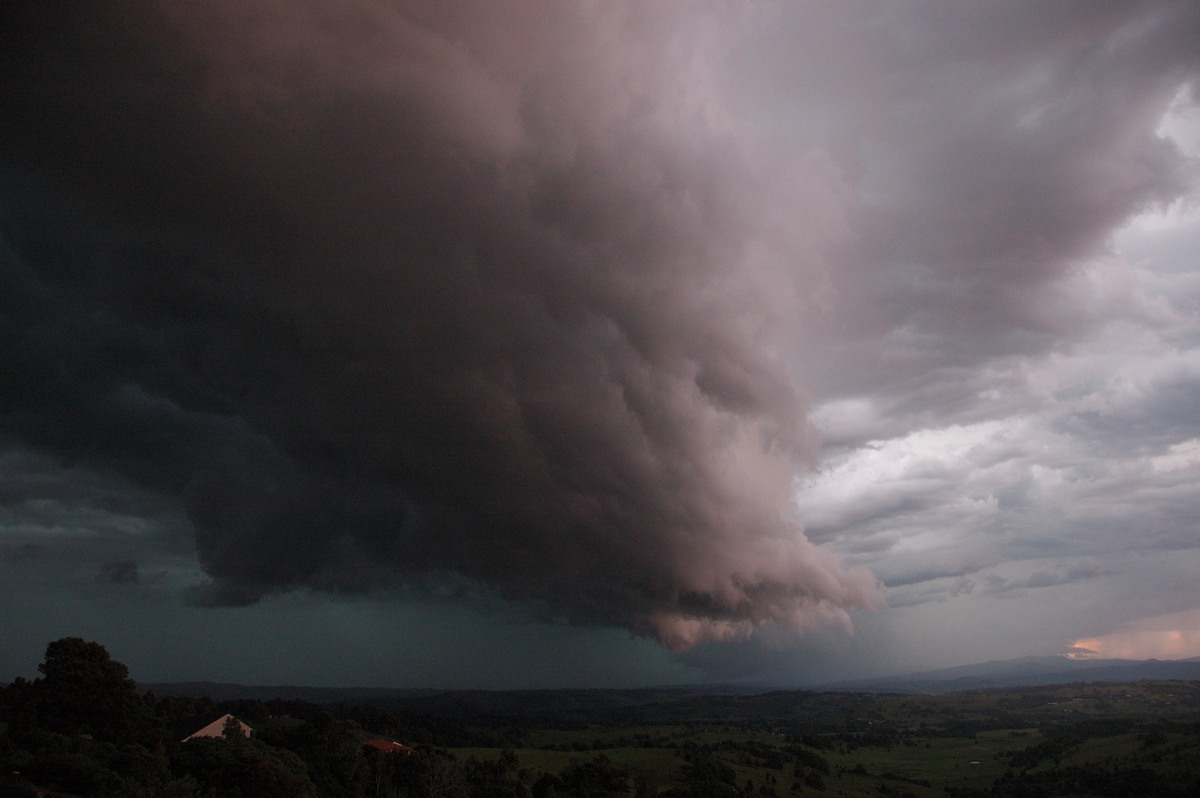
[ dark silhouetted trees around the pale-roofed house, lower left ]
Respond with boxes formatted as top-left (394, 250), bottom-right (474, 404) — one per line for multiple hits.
top-left (0, 637), bottom-right (546, 798)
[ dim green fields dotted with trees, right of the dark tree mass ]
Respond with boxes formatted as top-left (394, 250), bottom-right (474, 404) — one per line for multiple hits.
top-left (454, 683), bottom-right (1200, 798)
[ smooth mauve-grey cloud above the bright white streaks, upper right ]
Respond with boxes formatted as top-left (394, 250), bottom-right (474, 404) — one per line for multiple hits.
top-left (770, 4), bottom-right (1200, 405)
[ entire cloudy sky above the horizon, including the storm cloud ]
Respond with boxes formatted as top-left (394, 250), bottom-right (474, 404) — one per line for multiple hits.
top-left (0, 0), bottom-right (1200, 689)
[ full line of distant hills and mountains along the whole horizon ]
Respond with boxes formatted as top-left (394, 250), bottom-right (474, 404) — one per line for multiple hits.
top-left (139, 656), bottom-right (1200, 718)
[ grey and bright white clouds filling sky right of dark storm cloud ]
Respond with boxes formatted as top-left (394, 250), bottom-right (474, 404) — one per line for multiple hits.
top-left (772, 4), bottom-right (1200, 657)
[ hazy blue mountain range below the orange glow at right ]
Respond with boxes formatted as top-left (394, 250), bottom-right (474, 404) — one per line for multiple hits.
top-left (820, 656), bottom-right (1200, 694)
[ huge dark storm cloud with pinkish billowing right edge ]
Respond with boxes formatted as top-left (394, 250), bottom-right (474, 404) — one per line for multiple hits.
top-left (0, 0), bottom-right (877, 647)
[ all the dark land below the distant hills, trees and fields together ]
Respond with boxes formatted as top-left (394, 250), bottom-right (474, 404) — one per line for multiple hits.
top-left (0, 638), bottom-right (1200, 798)
